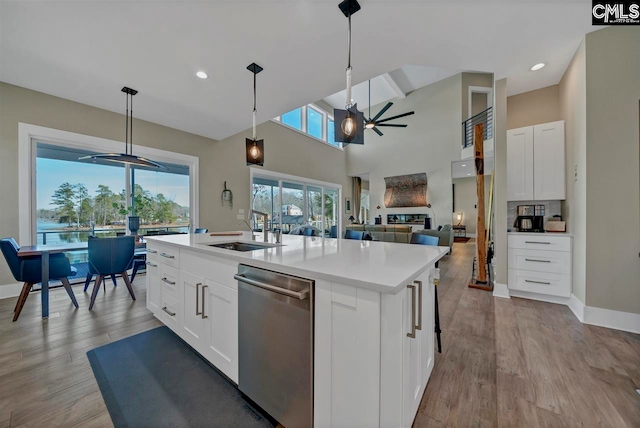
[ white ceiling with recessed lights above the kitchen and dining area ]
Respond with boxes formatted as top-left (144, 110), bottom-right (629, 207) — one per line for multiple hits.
top-left (0, 0), bottom-right (596, 139)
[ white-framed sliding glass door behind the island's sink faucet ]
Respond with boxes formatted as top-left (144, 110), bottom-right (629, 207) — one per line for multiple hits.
top-left (251, 173), bottom-right (341, 236)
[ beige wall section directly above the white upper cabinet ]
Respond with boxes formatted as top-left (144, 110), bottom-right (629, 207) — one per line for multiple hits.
top-left (507, 85), bottom-right (562, 129)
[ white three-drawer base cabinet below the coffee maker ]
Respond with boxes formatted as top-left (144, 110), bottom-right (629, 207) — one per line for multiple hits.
top-left (508, 234), bottom-right (571, 297)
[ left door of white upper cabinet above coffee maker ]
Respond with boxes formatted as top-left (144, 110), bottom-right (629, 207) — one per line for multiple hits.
top-left (507, 126), bottom-right (534, 201)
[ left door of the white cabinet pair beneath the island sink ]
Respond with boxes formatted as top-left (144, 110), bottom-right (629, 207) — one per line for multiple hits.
top-left (179, 271), bottom-right (206, 352)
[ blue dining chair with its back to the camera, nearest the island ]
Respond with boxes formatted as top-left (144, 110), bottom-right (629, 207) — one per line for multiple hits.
top-left (88, 236), bottom-right (136, 310)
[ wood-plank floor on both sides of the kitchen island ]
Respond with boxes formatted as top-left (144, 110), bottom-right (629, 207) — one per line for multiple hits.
top-left (0, 241), bottom-right (640, 428)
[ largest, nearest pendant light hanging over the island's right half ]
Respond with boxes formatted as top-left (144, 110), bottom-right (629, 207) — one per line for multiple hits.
top-left (333, 0), bottom-right (364, 145)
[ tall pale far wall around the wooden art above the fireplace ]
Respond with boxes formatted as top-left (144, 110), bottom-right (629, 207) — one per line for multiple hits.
top-left (347, 74), bottom-right (462, 231)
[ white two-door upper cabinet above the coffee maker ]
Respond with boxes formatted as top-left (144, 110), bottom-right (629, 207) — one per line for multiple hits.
top-left (507, 121), bottom-right (566, 201)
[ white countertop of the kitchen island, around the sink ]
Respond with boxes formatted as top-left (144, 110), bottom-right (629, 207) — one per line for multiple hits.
top-left (145, 232), bottom-right (449, 294)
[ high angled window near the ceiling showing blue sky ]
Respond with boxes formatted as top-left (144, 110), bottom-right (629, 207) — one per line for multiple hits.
top-left (274, 104), bottom-right (342, 149)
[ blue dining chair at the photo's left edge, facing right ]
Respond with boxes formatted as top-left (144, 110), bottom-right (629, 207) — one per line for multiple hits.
top-left (0, 238), bottom-right (78, 321)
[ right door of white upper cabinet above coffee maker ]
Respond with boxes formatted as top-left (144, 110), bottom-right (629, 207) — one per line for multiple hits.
top-left (528, 121), bottom-right (566, 200)
